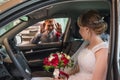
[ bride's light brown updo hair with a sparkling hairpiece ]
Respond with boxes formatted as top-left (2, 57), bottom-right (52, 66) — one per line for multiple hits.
top-left (77, 10), bottom-right (107, 35)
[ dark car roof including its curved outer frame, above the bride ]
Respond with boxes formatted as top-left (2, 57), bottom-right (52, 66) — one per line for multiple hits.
top-left (0, 0), bottom-right (110, 27)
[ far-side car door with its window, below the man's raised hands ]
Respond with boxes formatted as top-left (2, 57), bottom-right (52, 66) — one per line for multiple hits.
top-left (16, 18), bottom-right (70, 69)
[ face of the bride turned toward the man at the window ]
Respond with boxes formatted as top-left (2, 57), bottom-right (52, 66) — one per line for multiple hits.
top-left (79, 26), bottom-right (89, 40)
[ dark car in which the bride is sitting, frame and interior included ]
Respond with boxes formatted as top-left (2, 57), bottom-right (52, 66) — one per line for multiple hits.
top-left (0, 0), bottom-right (120, 80)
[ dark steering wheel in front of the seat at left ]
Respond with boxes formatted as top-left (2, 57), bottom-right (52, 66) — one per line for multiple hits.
top-left (4, 38), bottom-right (31, 80)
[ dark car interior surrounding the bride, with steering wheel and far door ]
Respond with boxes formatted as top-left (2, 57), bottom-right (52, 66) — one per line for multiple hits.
top-left (0, 1), bottom-right (110, 79)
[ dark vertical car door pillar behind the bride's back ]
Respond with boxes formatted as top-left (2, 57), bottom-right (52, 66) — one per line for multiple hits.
top-left (107, 0), bottom-right (120, 80)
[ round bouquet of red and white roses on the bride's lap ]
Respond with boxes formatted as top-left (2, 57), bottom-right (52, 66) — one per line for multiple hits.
top-left (43, 52), bottom-right (73, 71)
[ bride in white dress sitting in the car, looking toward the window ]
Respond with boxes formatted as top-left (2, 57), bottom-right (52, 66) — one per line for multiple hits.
top-left (32, 10), bottom-right (108, 80)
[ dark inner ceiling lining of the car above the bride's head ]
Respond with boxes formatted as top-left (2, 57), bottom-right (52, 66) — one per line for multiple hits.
top-left (29, 0), bottom-right (110, 19)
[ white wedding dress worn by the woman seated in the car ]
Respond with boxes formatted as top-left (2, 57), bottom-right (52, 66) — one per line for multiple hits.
top-left (68, 42), bottom-right (108, 80)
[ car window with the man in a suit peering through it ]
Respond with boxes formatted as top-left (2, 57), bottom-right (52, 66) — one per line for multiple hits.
top-left (18, 18), bottom-right (68, 44)
